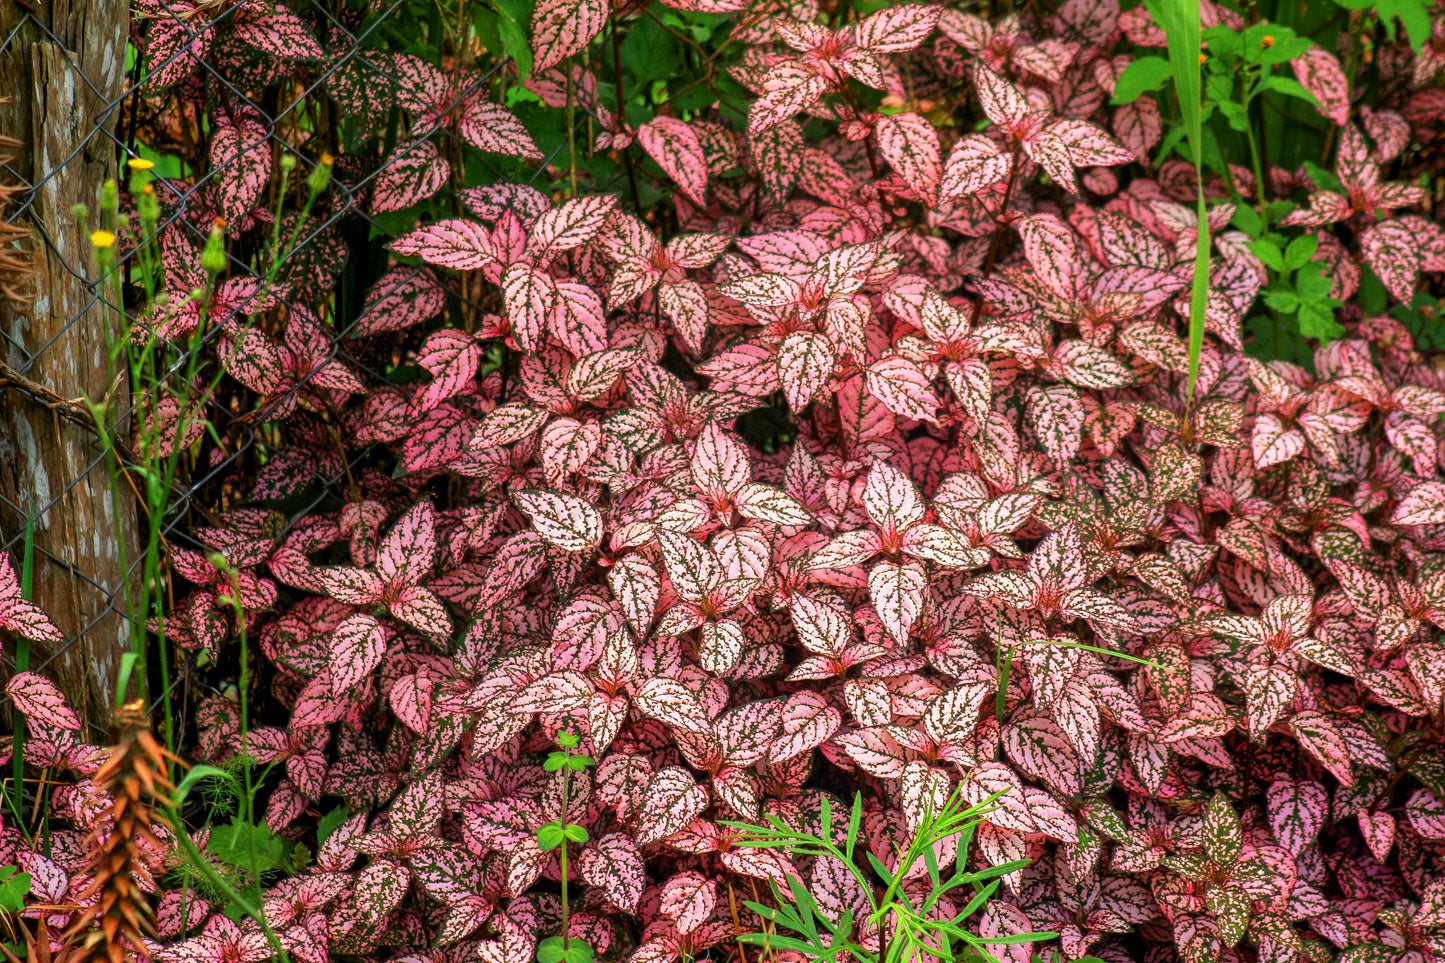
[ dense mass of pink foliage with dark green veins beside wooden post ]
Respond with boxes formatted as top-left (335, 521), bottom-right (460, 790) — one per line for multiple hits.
top-left (0, 0), bottom-right (1445, 963)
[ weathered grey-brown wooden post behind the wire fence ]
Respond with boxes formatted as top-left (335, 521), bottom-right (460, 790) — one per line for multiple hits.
top-left (0, 0), bottom-right (143, 724)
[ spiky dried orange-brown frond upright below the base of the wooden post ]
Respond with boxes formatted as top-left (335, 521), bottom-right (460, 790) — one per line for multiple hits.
top-left (64, 701), bottom-right (175, 963)
